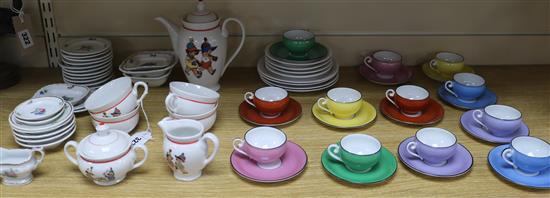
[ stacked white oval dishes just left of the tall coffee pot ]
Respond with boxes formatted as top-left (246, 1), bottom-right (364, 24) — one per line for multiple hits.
top-left (118, 51), bottom-right (178, 87)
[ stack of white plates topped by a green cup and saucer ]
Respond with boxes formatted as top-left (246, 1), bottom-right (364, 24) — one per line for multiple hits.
top-left (257, 30), bottom-right (339, 92)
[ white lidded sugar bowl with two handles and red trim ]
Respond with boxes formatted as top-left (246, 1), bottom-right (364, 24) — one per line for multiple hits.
top-left (64, 125), bottom-right (147, 186)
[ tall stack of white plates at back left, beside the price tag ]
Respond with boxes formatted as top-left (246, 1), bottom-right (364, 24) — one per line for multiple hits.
top-left (59, 37), bottom-right (113, 88)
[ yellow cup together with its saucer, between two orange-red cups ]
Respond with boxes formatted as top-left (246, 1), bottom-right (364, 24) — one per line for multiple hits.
top-left (311, 87), bottom-right (376, 128)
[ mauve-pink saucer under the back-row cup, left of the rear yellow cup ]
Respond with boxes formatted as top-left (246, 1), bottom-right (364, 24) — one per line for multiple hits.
top-left (359, 65), bottom-right (412, 85)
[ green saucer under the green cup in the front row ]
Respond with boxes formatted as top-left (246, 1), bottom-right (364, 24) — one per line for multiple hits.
top-left (321, 147), bottom-right (397, 184)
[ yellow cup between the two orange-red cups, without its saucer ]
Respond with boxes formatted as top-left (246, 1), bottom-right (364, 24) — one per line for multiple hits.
top-left (317, 87), bottom-right (363, 119)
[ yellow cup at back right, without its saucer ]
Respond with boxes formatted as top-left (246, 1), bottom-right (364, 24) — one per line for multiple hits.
top-left (429, 52), bottom-right (464, 76)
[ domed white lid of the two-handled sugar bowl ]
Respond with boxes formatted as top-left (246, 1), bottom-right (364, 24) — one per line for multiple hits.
top-left (78, 124), bottom-right (131, 160)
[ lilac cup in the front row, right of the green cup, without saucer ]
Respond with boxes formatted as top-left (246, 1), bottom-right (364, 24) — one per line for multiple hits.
top-left (407, 127), bottom-right (457, 166)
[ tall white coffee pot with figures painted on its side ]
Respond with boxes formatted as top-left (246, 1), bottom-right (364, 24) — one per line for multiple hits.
top-left (155, 0), bottom-right (245, 90)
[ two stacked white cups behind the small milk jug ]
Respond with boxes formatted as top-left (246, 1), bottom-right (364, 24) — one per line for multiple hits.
top-left (164, 82), bottom-right (220, 131)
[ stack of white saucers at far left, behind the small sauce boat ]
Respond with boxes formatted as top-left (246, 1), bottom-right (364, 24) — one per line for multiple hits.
top-left (9, 97), bottom-right (76, 149)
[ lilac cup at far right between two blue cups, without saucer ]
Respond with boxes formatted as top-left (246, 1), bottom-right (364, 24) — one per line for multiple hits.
top-left (472, 105), bottom-right (522, 137)
